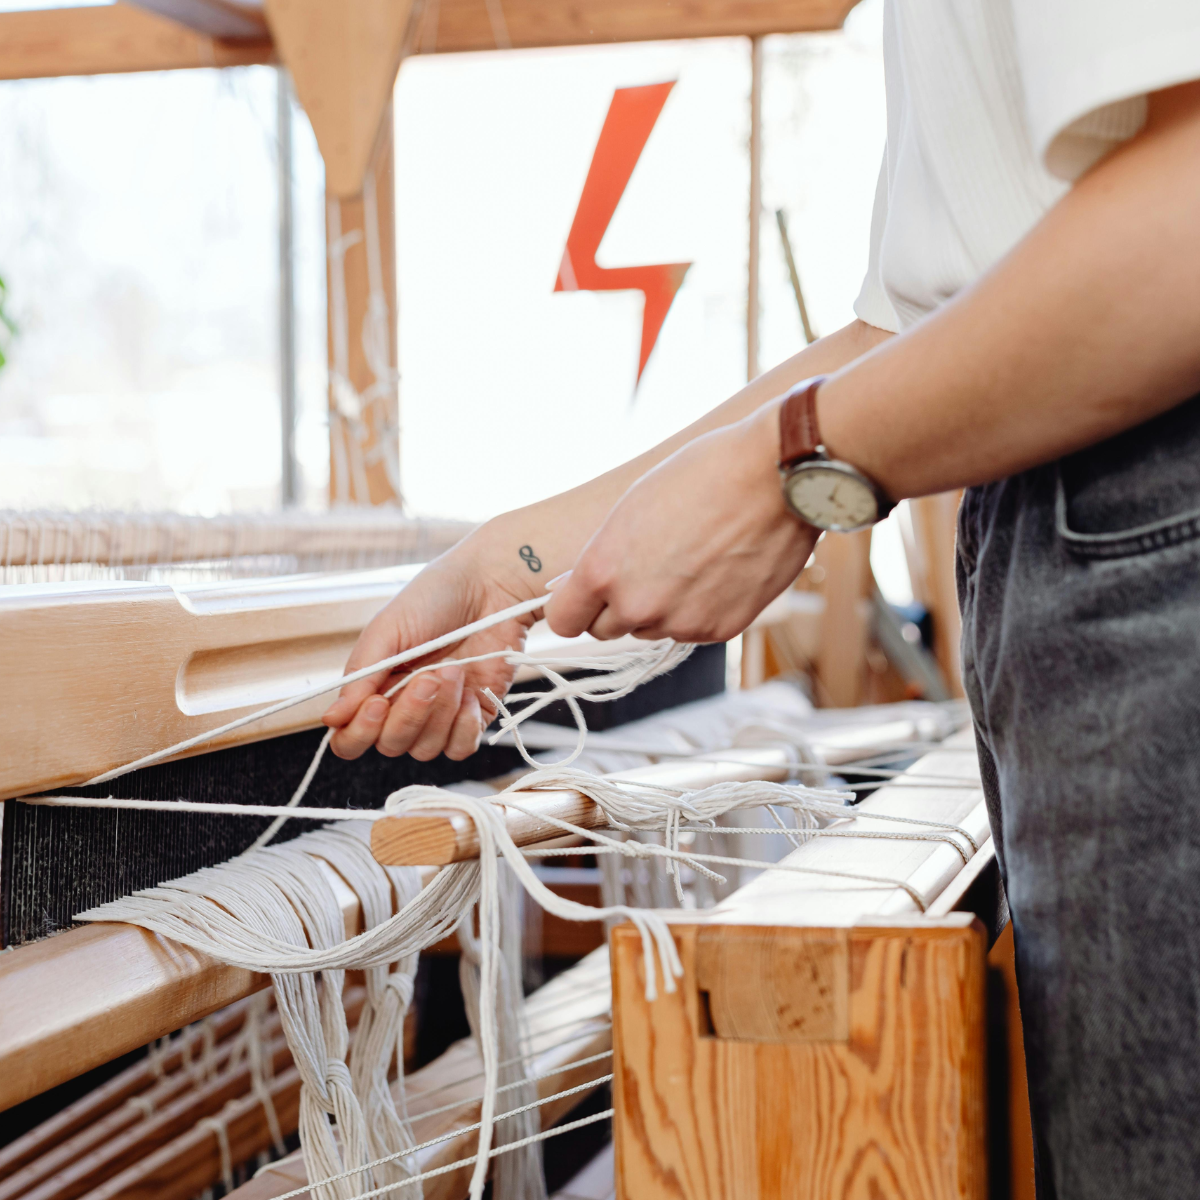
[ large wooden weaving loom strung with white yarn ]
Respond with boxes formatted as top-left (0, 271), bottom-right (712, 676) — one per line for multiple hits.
top-left (0, 0), bottom-right (1012, 1200)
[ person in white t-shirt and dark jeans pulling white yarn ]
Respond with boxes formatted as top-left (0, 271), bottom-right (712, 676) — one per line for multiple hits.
top-left (325, 0), bottom-right (1200, 1200)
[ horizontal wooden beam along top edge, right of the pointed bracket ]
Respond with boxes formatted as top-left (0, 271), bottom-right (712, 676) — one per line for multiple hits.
top-left (415, 0), bottom-right (857, 54)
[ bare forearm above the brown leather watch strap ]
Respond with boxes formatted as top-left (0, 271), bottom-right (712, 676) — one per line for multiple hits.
top-left (818, 84), bottom-right (1200, 498)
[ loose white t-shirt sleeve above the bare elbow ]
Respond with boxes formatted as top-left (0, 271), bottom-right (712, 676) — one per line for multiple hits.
top-left (1013, 0), bottom-right (1200, 182)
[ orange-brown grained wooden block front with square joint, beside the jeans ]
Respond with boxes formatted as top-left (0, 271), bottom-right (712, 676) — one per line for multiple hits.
top-left (612, 914), bottom-right (986, 1200)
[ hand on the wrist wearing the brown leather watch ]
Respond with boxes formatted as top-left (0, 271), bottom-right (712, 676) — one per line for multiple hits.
top-left (546, 401), bottom-right (820, 642)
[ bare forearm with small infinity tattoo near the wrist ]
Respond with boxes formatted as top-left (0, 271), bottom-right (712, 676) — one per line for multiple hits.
top-left (476, 320), bottom-right (892, 584)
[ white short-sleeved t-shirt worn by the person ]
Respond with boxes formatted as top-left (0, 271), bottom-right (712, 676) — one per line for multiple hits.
top-left (854, 0), bottom-right (1200, 332)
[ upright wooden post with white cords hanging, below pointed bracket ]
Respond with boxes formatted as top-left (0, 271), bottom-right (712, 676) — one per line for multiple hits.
top-left (325, 108), bottom-right (401, 504)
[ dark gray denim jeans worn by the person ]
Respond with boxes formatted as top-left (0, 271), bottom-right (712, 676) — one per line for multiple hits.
top-left (959, 397), bottom-right (1200, 1200)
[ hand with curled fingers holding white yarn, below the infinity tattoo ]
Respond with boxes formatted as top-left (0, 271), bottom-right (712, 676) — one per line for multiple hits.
top-left (322, 527), bottom-right (534, 762)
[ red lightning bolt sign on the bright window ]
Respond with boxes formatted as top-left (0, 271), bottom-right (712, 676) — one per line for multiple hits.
top-left (554, 80), bottom-right (691, 382)
